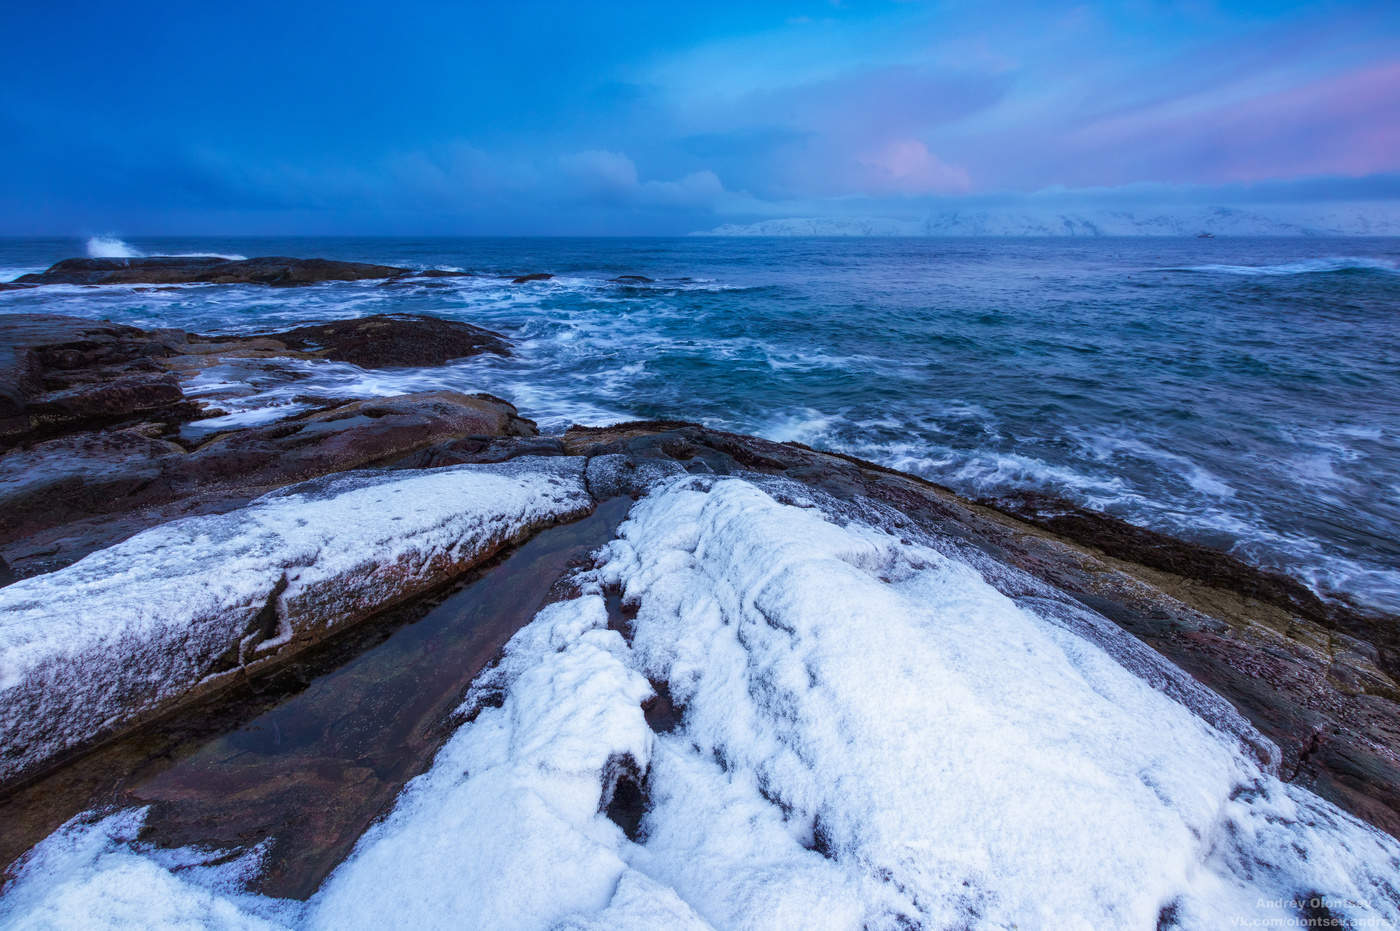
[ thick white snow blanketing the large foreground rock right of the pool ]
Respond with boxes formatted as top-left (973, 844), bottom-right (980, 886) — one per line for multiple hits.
top-left (0, 476), bottom-right (1400, 928)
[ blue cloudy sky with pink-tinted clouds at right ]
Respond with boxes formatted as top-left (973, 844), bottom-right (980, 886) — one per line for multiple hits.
top-left (0, 0), bottom-right (1400, 235)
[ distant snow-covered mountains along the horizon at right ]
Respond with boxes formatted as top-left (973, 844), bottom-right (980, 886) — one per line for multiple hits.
top-left (692, 204), bottom-right (1400, 237)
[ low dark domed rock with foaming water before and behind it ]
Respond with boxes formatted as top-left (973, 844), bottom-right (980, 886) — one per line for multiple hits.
top-left (250, 314), bottom-right (510, 368)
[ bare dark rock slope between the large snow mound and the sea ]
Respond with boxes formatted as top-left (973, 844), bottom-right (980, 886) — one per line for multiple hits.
top-left (564, 421), bottom-right (1400, 837)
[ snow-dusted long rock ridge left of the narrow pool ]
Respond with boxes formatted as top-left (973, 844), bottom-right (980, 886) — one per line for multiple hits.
top-left (0, 458), bottom-right (592, 777)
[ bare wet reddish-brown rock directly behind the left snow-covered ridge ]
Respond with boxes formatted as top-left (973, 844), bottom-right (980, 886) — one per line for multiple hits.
top-left (0, 391), bottom-right (536, 575)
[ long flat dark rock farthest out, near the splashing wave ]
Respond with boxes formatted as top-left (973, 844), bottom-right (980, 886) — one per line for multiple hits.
top-left (15, 256), bottom-right (412, 287)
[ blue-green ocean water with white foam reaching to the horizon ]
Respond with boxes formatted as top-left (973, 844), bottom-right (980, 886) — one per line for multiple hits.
top-left (0, 238), bottom-right (1400, 610)
